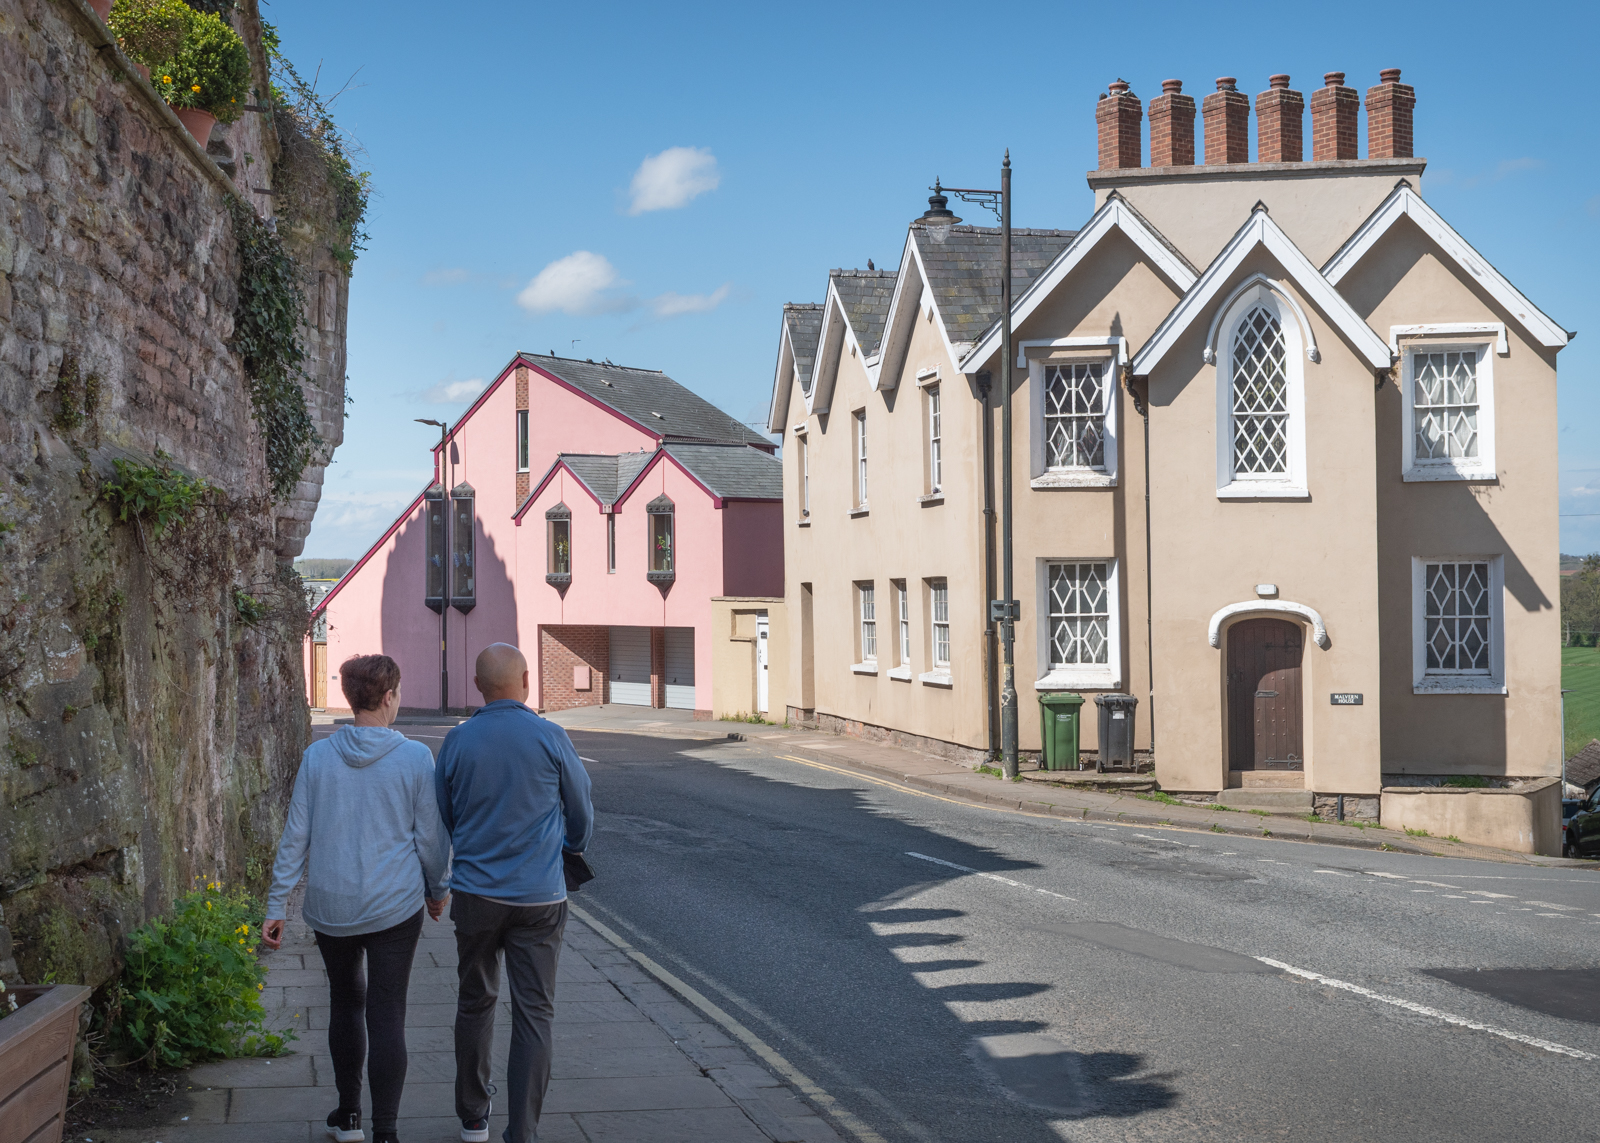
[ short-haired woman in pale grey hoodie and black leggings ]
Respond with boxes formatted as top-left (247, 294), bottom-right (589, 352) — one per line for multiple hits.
top-left (261, 655), bottom-right (450, 1143)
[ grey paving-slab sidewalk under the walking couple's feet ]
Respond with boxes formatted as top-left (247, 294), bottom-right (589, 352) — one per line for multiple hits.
top-left (88, 898), bottom-right (840, 1143)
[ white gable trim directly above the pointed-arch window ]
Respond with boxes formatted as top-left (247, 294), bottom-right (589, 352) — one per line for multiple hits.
top-left (1133, 207), bottom-right (1392, 376)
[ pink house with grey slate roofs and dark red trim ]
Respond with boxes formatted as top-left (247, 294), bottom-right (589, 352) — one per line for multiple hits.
top-left (307, 354), bottom-right (784, 717)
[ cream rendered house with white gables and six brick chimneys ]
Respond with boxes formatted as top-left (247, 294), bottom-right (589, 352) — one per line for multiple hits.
top-left (770, 70), bottom-right (1570, 816)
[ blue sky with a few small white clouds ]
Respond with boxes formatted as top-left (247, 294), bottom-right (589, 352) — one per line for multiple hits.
top-left (275, 0), bottom-right (1600, 557)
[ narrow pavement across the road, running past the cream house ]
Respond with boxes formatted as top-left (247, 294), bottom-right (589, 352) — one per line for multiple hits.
top-left (550, 706), bottom-right (1595, 869)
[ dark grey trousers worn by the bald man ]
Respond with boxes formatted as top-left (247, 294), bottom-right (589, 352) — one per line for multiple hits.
top-left (450, 893), bottom-right (566, 1143)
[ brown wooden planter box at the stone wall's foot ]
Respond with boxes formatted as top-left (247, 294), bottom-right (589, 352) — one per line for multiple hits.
top-left (0, 985), bottom-right (90, 1143)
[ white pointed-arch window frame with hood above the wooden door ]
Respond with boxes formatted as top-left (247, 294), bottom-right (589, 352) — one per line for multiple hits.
top-left (1216, 282), bottom-right (1310, 499)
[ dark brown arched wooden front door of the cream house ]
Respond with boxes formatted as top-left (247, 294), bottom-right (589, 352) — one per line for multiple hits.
top-left (1227, 620), bottom-right (1306, 770)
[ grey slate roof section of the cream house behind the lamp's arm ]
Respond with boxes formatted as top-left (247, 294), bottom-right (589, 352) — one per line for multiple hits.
top-left (910, 223), bottom-right (1077, 341)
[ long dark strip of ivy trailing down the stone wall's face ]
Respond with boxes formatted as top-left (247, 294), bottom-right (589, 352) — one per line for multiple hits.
top-left (229, 199), bottom-right (322, 499)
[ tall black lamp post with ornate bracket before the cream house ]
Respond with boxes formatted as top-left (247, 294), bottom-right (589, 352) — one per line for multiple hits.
top-left (918, 147), bottom-right (1022, 778)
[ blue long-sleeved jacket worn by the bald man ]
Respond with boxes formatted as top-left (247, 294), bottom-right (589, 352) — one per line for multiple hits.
top-left (434, 698), bottom-right (595, 904)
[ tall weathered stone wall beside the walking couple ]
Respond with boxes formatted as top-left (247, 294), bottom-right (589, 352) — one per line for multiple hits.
top-left (0, 0), bottom-right (346, 985)
